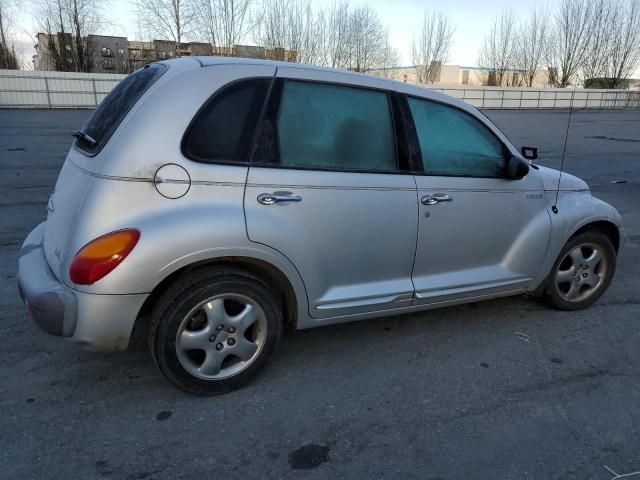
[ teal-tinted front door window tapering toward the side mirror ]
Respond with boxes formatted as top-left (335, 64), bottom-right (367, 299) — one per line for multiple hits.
top-left (408, 98), bottom-right (505, 177)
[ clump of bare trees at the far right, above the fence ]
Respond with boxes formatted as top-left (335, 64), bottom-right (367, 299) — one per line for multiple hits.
top-left (478, 0), bottom-right (640, 88)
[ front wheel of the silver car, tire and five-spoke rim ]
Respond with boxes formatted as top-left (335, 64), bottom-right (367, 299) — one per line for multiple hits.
top-left (544, 230), bottom-right (616, 311)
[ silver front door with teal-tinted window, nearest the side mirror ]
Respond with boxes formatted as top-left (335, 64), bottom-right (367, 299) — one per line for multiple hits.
top-left (407, 97), bottom-right (551, 304)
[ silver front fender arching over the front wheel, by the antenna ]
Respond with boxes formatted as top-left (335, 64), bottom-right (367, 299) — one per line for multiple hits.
top-left (533, 191), bottom-right (624, 288)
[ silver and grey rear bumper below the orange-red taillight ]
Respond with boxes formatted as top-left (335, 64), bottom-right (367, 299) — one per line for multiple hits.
top-left (18, 223), bottom-right (148, 351)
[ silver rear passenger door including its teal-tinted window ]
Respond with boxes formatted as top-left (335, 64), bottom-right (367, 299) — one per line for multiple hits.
top-left (244, 68), bottom-right (418, 319)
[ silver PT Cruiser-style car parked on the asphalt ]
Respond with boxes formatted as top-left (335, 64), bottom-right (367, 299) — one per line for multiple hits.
top-left (18, 57), bottom-right (624, 394)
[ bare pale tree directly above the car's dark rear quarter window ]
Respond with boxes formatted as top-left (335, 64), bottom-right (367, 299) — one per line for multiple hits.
top-left (195, 0), bottom-right (252, 54)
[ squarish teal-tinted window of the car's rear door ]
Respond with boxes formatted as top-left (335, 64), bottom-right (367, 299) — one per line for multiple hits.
top-left (277, 81), bottom-right (397, 172)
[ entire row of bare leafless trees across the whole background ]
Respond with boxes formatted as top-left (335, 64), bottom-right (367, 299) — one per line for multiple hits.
top-left (0, 0), bottom-right (640, 88)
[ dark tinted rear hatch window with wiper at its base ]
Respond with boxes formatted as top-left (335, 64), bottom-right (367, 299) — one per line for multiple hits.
top-left (76, 63), bottom-right (167, 154)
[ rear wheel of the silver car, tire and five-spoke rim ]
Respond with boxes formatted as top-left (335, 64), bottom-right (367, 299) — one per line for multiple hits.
top-left (149, 266), bottom-right (283, 395)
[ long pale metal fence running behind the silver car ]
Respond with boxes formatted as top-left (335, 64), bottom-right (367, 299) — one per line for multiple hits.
top-left (0, 70), bottom-right (640, 109)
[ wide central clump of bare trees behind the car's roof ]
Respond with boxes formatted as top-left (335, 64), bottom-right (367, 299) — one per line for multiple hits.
top-left (134, 0), bottom-right (400, 72)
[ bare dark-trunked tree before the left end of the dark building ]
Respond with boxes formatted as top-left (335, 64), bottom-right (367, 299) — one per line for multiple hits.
top-left (38, 0), bottom-right (108, 72)
